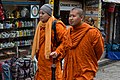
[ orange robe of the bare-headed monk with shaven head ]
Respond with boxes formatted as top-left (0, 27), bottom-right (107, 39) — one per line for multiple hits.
top-left (63, 23), bottom-right (104, 80)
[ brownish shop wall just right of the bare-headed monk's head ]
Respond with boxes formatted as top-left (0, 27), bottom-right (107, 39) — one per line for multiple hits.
top-left (85, 0), bottom-right (101, 28)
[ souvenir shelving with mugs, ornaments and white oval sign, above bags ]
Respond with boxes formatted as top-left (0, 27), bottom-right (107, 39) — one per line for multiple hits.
top-left (0, 0), bottom-right (40, 56)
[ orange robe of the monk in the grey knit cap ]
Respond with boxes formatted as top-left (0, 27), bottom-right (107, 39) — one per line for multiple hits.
top-left (35, 22), bottom-right (69, 80)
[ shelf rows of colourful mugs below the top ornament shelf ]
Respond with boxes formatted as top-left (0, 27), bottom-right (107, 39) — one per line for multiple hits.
top-left (0, 18), bottom-right (35, 59)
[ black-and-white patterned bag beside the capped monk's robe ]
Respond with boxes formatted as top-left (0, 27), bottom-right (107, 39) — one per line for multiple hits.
top-left (11, 58), bottom-right (34, 79)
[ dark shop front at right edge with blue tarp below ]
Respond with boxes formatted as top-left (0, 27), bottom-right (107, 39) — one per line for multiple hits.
top-left (103, 0), bottom-right (120, 60)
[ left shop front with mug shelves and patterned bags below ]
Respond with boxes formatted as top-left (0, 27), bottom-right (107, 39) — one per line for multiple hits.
top-left (0, 0), bottom-right (42, 80)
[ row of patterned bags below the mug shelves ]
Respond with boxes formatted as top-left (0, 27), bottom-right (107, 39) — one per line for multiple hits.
top-left (0, 57), bottom-right (36, 80)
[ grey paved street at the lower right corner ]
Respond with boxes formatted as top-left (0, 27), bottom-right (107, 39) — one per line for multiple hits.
top-left (95, 60), bottom-right (120, 80)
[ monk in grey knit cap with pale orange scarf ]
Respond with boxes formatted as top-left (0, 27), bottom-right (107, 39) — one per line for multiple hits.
top-left (31, 4), bottom-right (69, 80)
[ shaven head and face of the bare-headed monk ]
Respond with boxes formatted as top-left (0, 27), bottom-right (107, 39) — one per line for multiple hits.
top-left (69, 9), bottom-right (82, 27)
